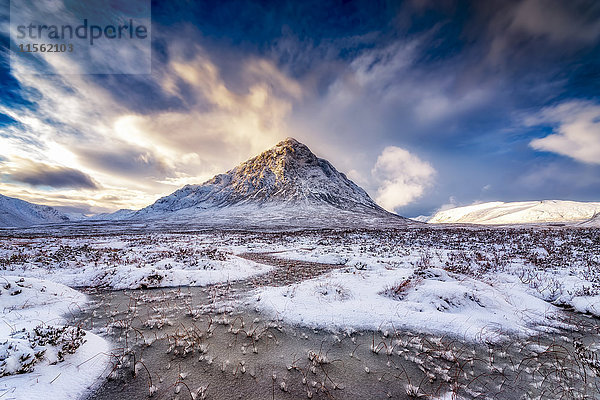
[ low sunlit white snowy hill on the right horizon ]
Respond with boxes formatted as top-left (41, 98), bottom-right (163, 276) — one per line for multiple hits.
top-left (428, 200), bottom-right (600, 225)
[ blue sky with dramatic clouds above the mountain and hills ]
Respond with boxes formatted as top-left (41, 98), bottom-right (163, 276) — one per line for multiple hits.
top-left (0, 0), bottom-right (600, 217)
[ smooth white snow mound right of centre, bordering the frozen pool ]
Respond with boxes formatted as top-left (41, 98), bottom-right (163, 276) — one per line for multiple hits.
top-left (256, 266), bottom-right (558, 342)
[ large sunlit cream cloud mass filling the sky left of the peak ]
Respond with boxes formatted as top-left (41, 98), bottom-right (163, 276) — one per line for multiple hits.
top-left (0, 32), bottom-right (303, 210)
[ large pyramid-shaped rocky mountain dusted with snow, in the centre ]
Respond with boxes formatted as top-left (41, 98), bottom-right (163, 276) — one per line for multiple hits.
top-left (129, 138), bottom-right (407, 226)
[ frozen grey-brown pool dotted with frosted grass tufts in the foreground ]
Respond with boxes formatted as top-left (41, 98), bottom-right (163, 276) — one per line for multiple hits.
top-left (78, 283), bottom-right (600, 400)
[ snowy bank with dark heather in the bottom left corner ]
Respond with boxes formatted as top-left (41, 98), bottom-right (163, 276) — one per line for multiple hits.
top-left (0, 275), bottom-right (110, 400)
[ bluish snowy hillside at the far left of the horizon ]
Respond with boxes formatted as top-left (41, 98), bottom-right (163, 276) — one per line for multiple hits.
top-left (0, 194), bottom-right (69, 228)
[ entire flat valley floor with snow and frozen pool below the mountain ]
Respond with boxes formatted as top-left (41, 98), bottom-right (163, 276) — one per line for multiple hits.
top-left (0, 227), bottom-right (600, 399)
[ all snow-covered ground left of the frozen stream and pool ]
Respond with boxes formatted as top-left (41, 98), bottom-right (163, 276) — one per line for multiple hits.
top-left (0, 235), bottom-right (271, 400)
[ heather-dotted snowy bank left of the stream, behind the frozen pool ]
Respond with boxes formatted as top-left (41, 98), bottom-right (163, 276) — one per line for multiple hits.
top-left (0, 235), bottom-right (271, 289)
